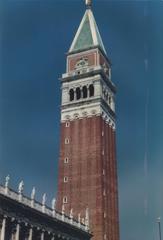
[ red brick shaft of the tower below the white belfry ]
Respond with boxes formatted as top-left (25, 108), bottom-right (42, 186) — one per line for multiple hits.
top-left (57, 117), bottom-right (119, 240)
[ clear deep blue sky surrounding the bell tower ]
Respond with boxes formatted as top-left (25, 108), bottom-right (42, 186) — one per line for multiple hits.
top-left (0, 0), bottom-right (163, 240)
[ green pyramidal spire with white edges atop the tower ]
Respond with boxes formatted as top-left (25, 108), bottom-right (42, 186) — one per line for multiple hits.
top-left (69, 8), bottom-right (106, 54)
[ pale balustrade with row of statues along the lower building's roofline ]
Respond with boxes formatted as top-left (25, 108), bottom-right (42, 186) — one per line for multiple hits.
top-left (0, 176), bottom-right (89, 233)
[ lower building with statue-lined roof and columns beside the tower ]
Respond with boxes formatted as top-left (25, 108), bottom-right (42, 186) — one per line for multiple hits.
top-left (0, 181), bottom-right (91, 240)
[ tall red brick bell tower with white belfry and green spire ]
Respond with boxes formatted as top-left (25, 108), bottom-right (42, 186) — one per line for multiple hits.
top-left (57, 0), bottom-right (119, 240)
